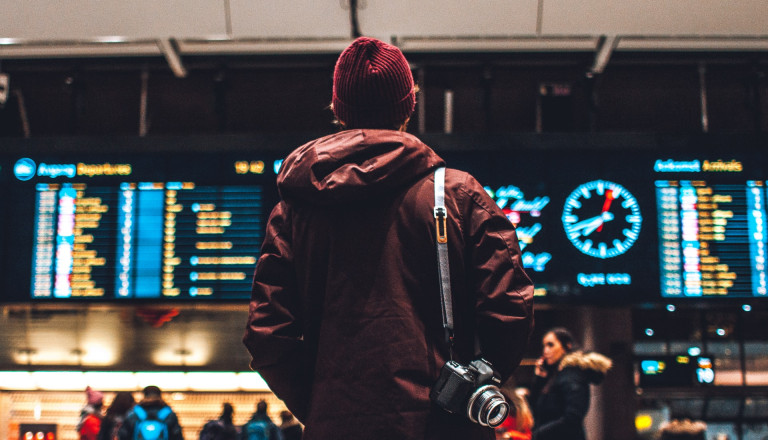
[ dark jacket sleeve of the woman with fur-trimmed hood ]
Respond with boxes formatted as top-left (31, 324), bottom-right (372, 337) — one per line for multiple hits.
top-left (533, 368), bottom-right (589, 440)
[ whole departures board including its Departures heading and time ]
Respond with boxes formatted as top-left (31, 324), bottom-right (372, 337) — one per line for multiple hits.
top-left (1, 155), bottom-right (275, 301)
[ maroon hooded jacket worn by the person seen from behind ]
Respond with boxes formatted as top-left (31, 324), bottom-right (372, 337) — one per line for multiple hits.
top-left (243, 130), bottom-right (533, 440)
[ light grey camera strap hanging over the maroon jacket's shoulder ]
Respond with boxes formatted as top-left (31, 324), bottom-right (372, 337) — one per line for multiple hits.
top-left (434, 167), bottom-right (453, 359)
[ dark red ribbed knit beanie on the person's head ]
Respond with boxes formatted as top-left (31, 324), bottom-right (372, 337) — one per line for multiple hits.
top-left (332, 37), bottom-right (416, 129)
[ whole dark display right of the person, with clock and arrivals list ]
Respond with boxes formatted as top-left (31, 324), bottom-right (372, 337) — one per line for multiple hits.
top-left (448, 141), bottom-right (768, 304)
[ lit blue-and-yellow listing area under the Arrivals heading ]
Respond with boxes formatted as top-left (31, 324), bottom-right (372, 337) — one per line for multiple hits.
top-left (656, 180), bottom-right (766, 298)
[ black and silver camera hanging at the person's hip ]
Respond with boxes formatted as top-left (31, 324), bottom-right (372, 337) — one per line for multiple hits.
top-left (429, 359), bottom-right (509, 428)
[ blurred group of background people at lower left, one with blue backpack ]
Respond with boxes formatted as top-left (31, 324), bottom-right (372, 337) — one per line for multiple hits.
top-left (76, 385), bottom-right (303, 440)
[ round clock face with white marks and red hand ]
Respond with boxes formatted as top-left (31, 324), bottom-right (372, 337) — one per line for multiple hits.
top-left (562, 180), bottom-right (643, 258)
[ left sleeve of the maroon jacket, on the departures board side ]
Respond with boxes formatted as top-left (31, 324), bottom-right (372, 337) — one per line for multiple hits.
top-left (243, 202), bottom-right (309, 420)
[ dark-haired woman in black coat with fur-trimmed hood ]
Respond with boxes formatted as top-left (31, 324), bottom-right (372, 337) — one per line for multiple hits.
top-left (531, 327), bottom-right (612, 440)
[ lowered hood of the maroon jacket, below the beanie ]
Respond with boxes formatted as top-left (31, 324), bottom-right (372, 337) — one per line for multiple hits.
top-left (277, 129), bottom-right (445, 205)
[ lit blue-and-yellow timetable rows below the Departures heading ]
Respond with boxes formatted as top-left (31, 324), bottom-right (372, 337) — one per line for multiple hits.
top-left (31, 182), bottom-right (263, 298)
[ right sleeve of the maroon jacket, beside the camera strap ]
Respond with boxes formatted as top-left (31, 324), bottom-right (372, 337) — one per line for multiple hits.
top-left (463, 176), bottom-right (533, 382)
